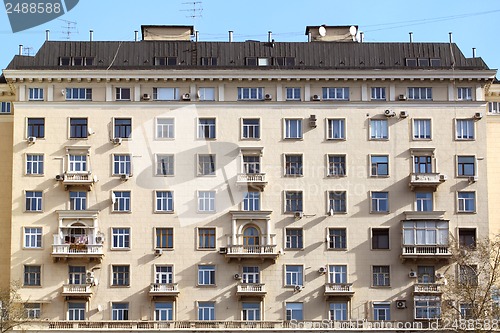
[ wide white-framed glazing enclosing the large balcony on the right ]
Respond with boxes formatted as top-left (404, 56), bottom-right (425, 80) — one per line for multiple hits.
top-left (403, 221), bottom-right (449, 247)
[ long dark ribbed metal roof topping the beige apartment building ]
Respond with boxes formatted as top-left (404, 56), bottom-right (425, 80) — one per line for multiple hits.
top-left (7, 41), bottom-right (489, 70)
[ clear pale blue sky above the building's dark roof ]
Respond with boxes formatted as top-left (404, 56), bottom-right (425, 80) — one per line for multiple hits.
top-left (0, 0), bottom-right (500, 69)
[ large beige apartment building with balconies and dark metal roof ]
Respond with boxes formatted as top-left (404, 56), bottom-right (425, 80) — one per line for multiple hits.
top-left (4, 26), bottom-right (495, 330)
